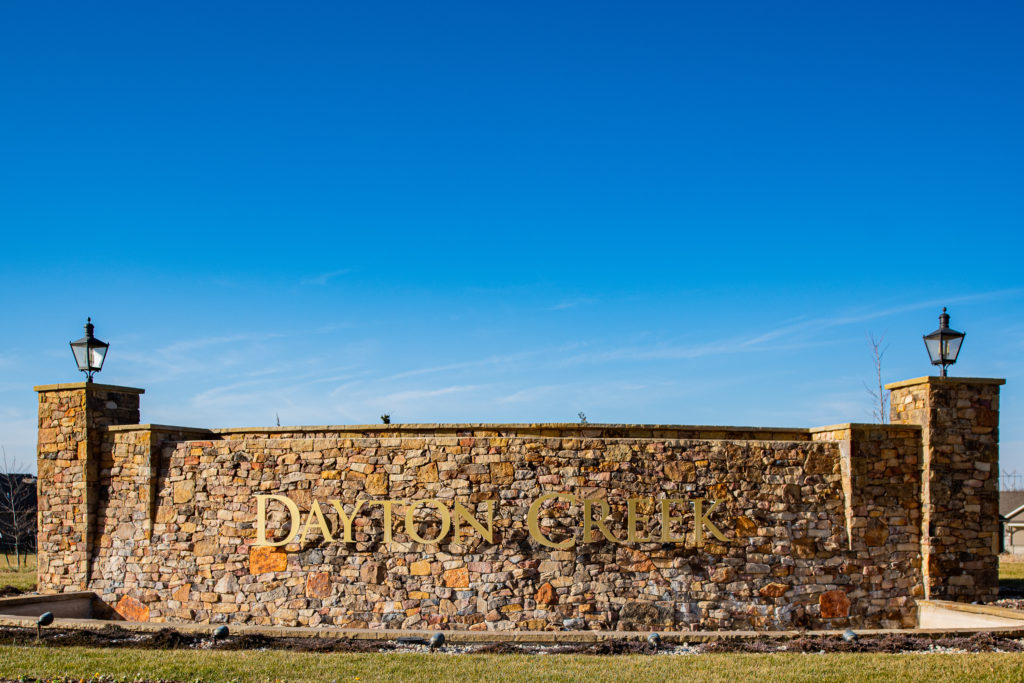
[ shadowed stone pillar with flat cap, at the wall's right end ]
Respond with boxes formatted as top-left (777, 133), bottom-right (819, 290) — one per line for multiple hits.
top-left (886, 377), bottom-right (1006, 602)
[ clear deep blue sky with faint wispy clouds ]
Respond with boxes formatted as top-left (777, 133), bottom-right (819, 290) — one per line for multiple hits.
top-left (0, 2), bottom-right (1024, 470)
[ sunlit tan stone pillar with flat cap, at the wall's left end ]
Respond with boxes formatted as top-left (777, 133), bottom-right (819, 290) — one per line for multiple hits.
top-left (35, 382), bottom-right (143, 593)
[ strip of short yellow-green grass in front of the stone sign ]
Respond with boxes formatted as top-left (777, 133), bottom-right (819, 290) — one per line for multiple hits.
top-left (0, 646), bottom-right (1024, 683)
